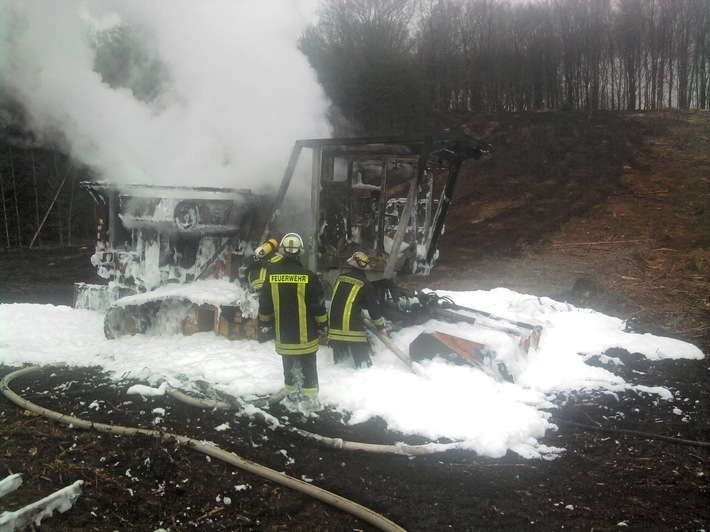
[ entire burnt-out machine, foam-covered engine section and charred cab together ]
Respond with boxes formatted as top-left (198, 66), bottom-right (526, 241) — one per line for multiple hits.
top-left (76, 134), bottom-right (539, 370)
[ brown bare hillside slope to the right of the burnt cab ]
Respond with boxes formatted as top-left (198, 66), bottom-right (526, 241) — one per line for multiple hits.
top-left (420, 112), bottom-right (710, 351)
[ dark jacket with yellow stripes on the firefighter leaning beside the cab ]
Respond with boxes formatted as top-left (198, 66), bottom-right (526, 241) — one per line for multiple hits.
top-left (328, 269), bottom-right (385, 342)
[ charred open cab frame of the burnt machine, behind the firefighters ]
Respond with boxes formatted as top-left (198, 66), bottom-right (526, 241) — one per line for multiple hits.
top-left (272, 135), bottom-right (486, 283)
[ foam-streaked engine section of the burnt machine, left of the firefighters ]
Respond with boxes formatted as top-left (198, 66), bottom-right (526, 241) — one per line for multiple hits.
top-left (74, 183), bottom-right (268, 338)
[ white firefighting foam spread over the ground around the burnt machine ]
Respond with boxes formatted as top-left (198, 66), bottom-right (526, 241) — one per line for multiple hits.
top-left (0, 294), bottom-right (703, 459)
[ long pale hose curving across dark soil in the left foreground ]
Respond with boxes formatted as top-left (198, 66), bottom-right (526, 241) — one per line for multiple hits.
top-left (0, 366), bottom-right (404, 532)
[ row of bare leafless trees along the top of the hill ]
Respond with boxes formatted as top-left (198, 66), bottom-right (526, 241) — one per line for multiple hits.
top-left (300, 0), bottom-right (710, 134)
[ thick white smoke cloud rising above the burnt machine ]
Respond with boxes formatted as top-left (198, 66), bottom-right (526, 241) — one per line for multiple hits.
top-left (0, 0), bottom-right (330, 191)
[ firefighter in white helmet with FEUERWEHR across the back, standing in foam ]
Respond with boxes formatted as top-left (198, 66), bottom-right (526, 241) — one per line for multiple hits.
top-left (259, 233), bottom-right (328, 414)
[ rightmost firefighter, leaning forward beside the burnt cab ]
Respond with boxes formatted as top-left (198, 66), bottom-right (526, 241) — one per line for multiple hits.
top-left (328, 251), bottom-right (387, 368)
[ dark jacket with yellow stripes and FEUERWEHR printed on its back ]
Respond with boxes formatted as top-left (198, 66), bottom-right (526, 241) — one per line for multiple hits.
top-left (259, 256), bottom-right (328, 355)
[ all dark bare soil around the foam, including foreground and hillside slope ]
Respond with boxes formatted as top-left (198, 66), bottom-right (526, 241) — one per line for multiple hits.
top-left (0, 112), bottom-right (710, 531)
